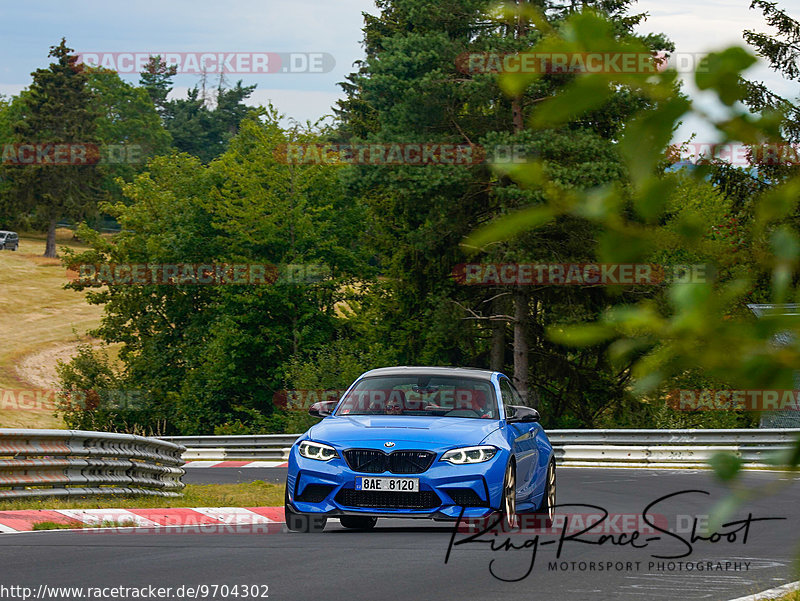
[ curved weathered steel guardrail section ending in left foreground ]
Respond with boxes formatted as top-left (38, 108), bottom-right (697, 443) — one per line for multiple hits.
top-left (0, 428), bottom-right (186, 499)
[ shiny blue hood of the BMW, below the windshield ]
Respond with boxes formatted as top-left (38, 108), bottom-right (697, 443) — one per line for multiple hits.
top-left (308, 415), bottom-right (500, 446)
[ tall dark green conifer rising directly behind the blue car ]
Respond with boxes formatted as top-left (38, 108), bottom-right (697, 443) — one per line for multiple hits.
top-left (338, 0), bottom-right (672, 422)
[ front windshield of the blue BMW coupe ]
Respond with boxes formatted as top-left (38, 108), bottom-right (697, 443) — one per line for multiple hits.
top-left (336, 374), bottom-right (498, 419)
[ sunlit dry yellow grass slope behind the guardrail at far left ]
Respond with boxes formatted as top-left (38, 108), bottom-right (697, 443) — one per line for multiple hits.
top-left (0, 230), bottom-right (102, 428)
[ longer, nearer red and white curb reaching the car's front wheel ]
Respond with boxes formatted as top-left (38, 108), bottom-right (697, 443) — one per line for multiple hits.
top-left (0, 507), bottom-right (284, 534)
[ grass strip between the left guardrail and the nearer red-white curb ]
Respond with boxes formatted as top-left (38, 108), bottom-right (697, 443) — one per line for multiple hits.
top-left (0, 480), bottom-right (284, 511)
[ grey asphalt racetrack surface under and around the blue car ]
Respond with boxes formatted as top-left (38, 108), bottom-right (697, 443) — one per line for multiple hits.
top-left (0, 468), bottom-right (800, 601)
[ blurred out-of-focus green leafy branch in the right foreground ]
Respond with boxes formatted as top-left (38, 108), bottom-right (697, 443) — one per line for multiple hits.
top-left (464, 8), bottom-right (800, 506)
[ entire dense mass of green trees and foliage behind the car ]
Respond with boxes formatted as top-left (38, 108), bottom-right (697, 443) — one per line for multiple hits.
top-left (0, 0), bottom-right (800, 434)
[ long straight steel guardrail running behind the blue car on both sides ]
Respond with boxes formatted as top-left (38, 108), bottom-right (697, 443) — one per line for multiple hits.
top-left (164, 429), bottom-right (800, 468)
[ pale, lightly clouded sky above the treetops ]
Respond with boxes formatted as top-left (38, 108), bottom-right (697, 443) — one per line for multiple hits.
top-left (0, 0), bottom-right (800, 142)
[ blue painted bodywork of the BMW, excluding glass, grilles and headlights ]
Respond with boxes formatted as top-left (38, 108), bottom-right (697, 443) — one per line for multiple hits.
top-left (286, 372), bottom-right (553, 519)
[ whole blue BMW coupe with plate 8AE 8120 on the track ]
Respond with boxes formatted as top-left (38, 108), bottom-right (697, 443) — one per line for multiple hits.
top-left (286, 367), bottom-right (556, 532)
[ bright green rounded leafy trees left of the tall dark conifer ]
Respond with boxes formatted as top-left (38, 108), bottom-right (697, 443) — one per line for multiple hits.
top-left (58, 109), bottom-right (363, 434)
